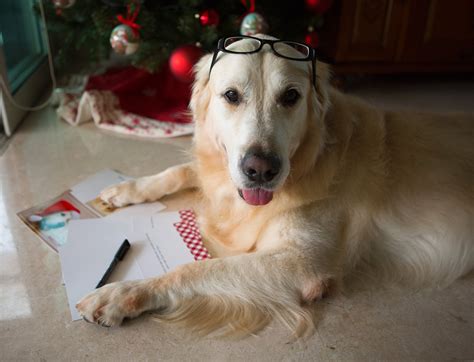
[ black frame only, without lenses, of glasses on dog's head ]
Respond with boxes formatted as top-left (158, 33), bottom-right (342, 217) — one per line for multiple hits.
top-left (209, 35), bottom-right (316, 90)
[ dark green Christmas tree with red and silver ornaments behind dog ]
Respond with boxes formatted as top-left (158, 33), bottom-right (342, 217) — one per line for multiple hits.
top-left (44, 0), bottom-right (332, 76)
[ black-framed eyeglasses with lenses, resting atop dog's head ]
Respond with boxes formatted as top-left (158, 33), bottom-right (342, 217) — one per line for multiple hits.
top-left (209, 35), bottom-right (316, 89)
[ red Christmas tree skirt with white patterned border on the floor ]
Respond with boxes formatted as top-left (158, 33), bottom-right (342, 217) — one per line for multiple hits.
top-left (58, 63), bottom-right (194, 138)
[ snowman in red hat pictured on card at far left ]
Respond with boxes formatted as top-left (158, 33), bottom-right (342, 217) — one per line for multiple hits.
top-left (28, 200), bottom-right (81, 247)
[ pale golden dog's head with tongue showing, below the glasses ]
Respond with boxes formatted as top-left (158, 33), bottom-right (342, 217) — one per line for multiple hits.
top-left (190, 36), bottom-right (328, 205)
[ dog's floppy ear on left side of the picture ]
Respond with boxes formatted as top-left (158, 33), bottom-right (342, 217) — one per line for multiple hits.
top-left (189, 54), bottom-right (211, 122)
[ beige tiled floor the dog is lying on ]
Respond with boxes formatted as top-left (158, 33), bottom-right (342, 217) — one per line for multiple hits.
top-left (0, 78), bottom-right (474, 361)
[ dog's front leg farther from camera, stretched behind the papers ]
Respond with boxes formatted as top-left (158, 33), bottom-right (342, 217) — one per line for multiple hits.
top-left (100, 162), bottom-right (197, 207)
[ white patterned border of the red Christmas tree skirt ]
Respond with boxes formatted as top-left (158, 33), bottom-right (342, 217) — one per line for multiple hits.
top-left (57, 90), bottom-right (194, 138)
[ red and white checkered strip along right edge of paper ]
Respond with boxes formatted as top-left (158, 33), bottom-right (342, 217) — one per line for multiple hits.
top-left (173, 210), bottom-right (211, 260)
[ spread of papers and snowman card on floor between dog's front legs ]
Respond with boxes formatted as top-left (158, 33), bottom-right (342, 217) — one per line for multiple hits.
top-left (18, 170), bottom-right (210, 320)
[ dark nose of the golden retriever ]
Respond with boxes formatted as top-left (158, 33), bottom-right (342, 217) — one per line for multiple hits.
top-left (241, 151), bottom-right (281, 182)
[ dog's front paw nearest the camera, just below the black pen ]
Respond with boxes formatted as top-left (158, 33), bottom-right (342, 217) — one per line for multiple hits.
top-left (76, 282), bottom-right (148, 327)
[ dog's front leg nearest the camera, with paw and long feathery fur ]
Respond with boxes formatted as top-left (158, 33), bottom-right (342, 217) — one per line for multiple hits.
top-left (76, 247), bottom-right (332, 331)
